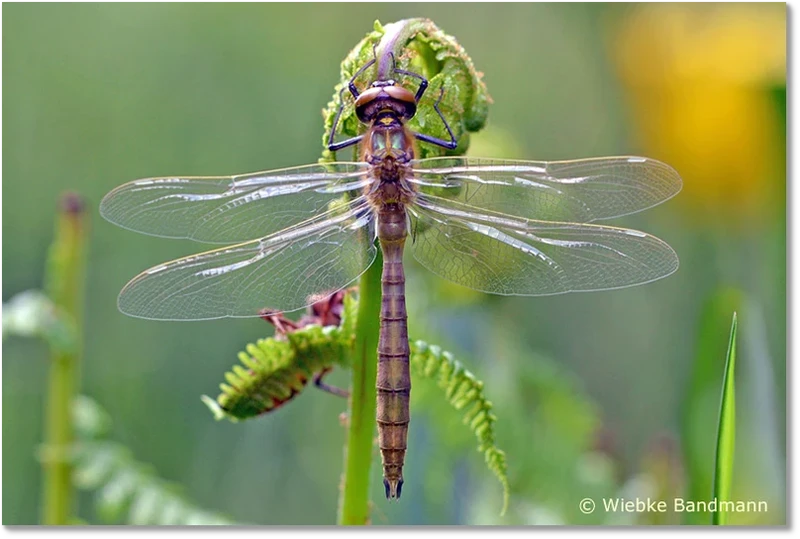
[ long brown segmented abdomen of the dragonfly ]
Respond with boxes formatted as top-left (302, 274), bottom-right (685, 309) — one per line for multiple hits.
top-left (377, 204), bottom-right (411, 498)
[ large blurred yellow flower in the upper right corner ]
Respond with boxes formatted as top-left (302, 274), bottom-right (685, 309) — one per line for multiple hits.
top-left (611, 2), bottom-right (786, 225)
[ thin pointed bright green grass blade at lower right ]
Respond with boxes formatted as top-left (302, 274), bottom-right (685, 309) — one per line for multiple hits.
top-left (711, 312), bottom-right (736, 525)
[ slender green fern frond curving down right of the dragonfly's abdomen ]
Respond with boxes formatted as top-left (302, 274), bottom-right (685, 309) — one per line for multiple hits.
top-left (410, 341), bottom-right (510, 515)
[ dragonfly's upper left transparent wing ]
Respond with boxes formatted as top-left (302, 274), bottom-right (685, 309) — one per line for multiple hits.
top-left (100, 163), bottom-right (370, 243)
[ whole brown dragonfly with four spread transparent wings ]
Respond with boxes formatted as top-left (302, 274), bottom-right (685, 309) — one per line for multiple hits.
top-left (100, 49), bottom-right (682, 499)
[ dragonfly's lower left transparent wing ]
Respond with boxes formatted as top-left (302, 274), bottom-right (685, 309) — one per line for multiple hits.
top-left (118, 197), bottom-right (376, 320)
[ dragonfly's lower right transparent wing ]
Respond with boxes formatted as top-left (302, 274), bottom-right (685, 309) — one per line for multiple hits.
top-left (409, 195), bottom-right (678, 296)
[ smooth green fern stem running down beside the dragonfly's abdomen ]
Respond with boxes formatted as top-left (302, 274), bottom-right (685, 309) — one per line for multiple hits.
top-left (338, 250), bottom-right (383, 525)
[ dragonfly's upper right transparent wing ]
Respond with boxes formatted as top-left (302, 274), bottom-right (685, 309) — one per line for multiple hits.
top-left (410, 157), bottom-right (681, 223)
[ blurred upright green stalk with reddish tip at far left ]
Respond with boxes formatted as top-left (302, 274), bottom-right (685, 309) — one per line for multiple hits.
top-left (42, 194), bottom-right (87, 525)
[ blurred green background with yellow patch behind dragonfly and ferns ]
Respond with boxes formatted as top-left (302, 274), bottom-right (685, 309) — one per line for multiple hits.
top-left (2, 2), bottom-right (786, 524)
